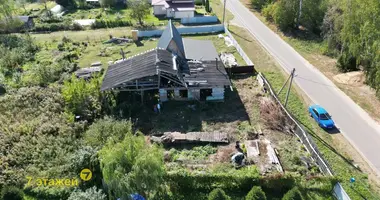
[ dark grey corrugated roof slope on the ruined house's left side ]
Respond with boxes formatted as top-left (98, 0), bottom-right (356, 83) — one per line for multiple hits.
top-left (100, 49), bottom-right (173, 91)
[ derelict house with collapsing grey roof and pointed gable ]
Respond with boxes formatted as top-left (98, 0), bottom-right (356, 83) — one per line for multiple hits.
top-left (101, 21), bottom-right (231, 101)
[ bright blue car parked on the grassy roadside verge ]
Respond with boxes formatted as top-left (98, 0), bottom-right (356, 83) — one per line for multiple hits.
top-left (309, 105), bottom-right (335, 129)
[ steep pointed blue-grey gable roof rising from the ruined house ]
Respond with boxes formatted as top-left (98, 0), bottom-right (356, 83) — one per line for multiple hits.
top-left (157, 20), bottom-right (185, 55)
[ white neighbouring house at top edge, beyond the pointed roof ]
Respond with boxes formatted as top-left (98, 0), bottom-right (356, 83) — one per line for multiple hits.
top-left (152, 0), bottom-right (195, 19)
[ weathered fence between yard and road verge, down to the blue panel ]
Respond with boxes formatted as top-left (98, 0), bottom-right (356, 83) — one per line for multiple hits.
top-left (258, 73), bottom-right (351, 200)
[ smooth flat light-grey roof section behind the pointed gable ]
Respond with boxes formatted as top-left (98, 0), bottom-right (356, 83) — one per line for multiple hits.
top-left (183, 38), bottom-right (219, 60)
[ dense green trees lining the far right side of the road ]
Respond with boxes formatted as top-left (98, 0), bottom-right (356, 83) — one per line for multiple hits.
top-left (251, 0), bottom-right (380, 98)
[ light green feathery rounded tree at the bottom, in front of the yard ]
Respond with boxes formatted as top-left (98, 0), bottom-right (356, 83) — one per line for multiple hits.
top-left (99, 132), bottom-right (165, 199)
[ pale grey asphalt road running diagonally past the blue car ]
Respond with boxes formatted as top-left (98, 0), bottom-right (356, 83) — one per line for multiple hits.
top-left (227, 0), bottom-right (380, 175)
